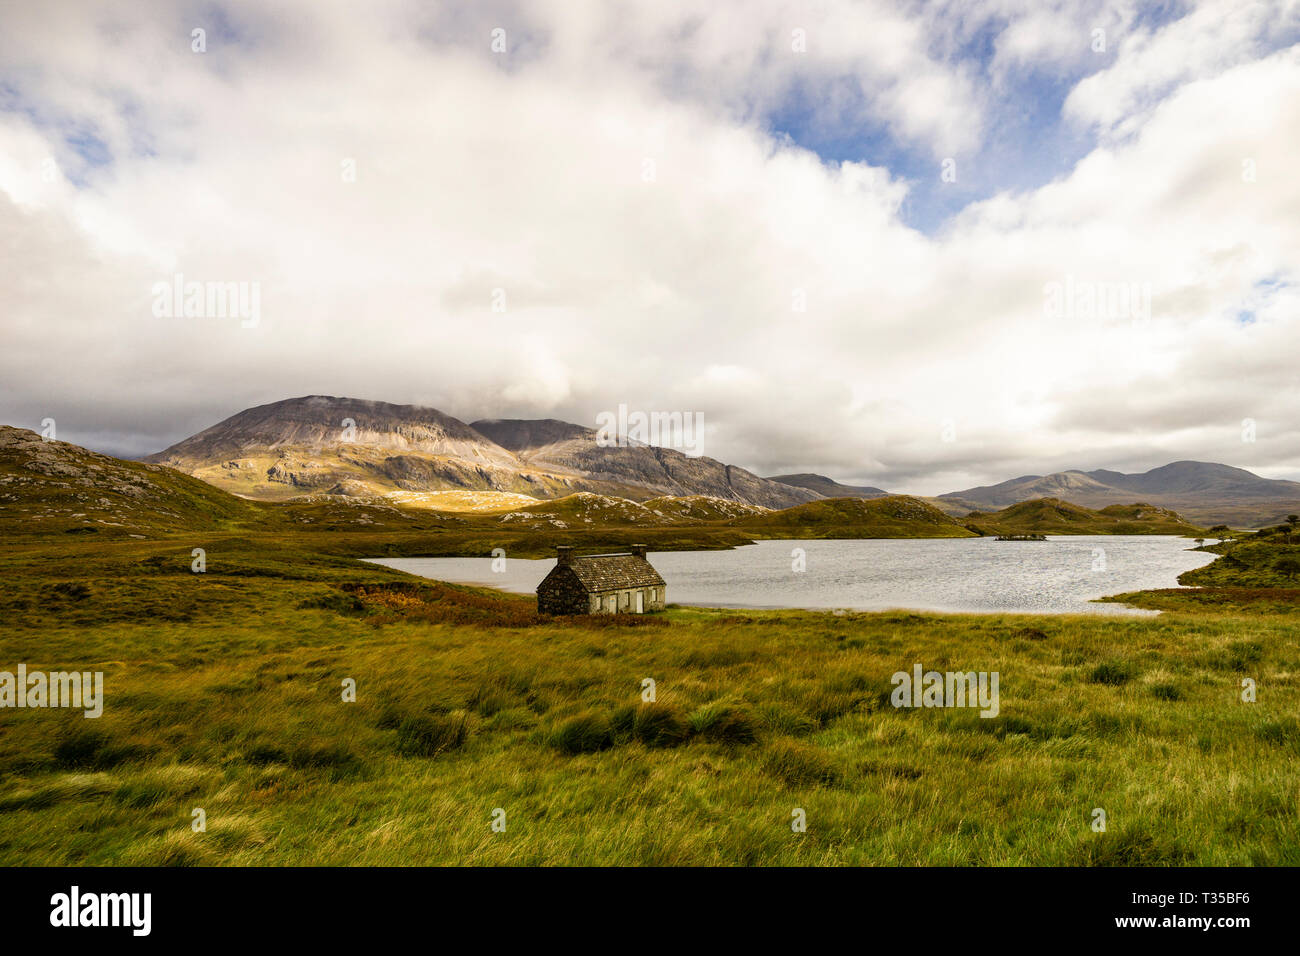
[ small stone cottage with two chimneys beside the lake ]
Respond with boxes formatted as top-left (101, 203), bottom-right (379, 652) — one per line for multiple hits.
top-left (537, 545), bottom-right (667, 614)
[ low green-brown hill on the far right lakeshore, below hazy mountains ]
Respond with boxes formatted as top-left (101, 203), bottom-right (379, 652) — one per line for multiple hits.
top-left (963, 498), bottom-right (1203, 535)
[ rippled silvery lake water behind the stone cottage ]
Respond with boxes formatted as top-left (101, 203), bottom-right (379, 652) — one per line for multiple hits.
top-left (364, 535), bottom-right (1214, 614)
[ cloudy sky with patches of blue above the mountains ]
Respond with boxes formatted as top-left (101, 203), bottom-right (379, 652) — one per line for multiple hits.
top-left (0, 0), bottom-right (1300, 494)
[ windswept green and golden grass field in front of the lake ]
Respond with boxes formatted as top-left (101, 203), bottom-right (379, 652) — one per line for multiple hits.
top-left (0, 535), bottom-right (1300, 865)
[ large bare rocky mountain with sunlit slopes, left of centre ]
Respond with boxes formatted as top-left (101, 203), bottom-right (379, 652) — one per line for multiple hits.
top-left (144, 395), bottom-right (816, 507)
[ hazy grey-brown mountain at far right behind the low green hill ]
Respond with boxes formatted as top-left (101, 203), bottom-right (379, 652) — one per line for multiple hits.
top-left (935, 462), bottom-right (1300, 527)
